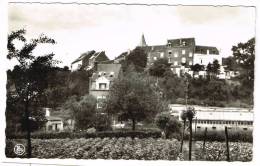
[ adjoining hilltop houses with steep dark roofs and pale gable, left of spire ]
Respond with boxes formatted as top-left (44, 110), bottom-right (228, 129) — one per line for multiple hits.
top-left (71, 50), bottom-right (109, 71)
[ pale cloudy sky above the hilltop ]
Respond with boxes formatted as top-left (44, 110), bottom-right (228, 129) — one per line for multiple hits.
top-left (8, 3), bottom-right (255, 66)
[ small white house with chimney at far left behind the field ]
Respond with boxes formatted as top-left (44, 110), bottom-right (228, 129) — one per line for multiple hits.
top-left (44, 108), bottom-right (63, 131)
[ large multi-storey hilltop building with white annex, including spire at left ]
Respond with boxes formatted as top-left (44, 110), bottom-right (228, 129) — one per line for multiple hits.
top-left (138, 35), bottom-right (222, 76)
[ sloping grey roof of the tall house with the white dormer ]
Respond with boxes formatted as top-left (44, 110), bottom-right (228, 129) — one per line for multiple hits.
top-left (91, 63), bottom-right (121, 80)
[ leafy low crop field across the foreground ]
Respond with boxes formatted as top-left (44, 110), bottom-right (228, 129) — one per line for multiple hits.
top-left (6, 137), bottom-right (252, 161)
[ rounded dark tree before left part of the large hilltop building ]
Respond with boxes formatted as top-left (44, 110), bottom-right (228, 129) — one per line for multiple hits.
top-left (149, 58), bottom-right (170, 77)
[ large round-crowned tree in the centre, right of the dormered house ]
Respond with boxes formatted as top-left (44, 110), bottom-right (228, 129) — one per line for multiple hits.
top-left (105, 68), bottom-right (162, 130)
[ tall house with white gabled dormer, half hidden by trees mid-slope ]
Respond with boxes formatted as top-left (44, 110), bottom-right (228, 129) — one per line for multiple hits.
top-left (89, 63), bottom-right (121, 108)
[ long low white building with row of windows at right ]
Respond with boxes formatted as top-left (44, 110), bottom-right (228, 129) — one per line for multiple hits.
top-left (169, 104), bottom-right (254, 130)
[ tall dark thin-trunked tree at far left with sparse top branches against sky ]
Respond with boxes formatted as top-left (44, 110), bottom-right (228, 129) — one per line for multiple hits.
top-left (7, 30), bottom-right (57, 158)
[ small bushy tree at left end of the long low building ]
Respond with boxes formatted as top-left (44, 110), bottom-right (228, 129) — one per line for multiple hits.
top-left (155, 112), bottom-right (181, 138)
